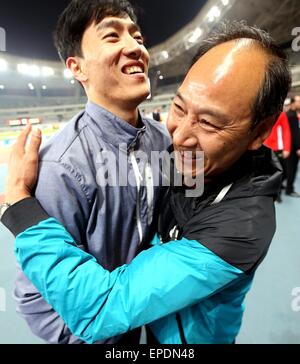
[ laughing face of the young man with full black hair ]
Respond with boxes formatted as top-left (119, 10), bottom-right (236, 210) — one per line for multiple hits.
top-left (67, 17), bottom-right (149, 113)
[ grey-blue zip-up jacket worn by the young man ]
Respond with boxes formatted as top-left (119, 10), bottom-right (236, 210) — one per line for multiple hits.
top-left (14, 102), bottom-right (171, 343)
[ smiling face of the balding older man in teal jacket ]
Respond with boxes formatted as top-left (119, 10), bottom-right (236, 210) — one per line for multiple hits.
top-left (168, 40), bottom-right (272, 179)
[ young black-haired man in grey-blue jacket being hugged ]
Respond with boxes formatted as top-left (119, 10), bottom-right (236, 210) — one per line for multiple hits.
top-left (8, 0), bottom-right (170, 343)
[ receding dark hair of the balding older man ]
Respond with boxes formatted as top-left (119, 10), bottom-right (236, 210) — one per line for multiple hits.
top-left (192, 21), bottom-right (291, 129)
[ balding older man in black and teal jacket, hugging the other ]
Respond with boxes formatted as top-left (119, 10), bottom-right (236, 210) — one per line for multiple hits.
top-left (2, 23), bottom-right (290, 344)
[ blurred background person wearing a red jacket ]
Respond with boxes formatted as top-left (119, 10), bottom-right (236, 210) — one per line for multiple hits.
top-left (264, 112), bottom-right (291, 202)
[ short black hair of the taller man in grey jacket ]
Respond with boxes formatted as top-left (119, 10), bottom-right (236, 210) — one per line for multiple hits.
top-left (54, 0), bottom-right (137, 62)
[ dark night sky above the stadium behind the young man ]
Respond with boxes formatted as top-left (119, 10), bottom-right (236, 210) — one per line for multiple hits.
top-left (0, 0), bottom-right (205, 60)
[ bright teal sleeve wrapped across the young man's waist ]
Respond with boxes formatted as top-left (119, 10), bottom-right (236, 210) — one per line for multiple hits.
top-left (15, 218), bottom-right (243, 343)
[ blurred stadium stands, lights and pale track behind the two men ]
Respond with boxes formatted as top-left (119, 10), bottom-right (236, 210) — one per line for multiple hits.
top-left (0, 0), bottom-right (300, 343)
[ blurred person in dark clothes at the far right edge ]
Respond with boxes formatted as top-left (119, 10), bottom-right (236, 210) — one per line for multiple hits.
top-left (285, 96), bottom-right (300, 198)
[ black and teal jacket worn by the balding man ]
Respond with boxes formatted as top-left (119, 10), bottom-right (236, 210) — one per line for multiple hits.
top-left (2, 147), bottom-right (281, 344)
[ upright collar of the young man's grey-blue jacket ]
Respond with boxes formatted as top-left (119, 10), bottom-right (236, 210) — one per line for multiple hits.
top-left (85, 101), bottom-right (146, 150)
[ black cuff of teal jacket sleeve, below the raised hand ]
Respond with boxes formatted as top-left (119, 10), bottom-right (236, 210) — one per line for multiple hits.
top-left (1, 197), bottom-right (49, 236)
